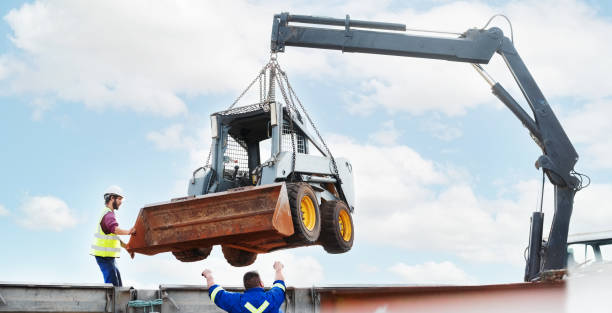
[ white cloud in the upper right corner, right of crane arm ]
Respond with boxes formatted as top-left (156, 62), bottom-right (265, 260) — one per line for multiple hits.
top-left (506, 0), bottom-right (612, 99)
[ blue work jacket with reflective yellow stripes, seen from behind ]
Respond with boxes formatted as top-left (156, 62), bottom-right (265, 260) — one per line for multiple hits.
top-left (208, 280), bottom-right (285, 313)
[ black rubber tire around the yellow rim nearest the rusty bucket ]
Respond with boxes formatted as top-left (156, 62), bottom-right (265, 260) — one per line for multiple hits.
top-left (287, 183), bottom-right (321, 244)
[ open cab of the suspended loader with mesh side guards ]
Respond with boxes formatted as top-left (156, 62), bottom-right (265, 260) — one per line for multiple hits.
top-left (203, 102), bottom-right (308, 195)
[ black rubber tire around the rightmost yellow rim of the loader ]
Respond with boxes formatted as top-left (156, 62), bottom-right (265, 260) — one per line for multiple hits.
top-left (319, 200), bottom-right (355, 254)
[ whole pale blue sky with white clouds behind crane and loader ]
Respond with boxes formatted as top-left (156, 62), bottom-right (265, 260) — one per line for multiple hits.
top-left (0, 0), bottom-right (612, 288)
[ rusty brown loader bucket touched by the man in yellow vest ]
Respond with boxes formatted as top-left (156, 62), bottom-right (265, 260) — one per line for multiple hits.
top-left (127, 183), bottom-right (293, 255)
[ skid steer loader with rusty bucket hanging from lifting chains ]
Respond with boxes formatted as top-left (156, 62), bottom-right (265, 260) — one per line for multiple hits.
top-left (128, 64), bottom-right (355, 266)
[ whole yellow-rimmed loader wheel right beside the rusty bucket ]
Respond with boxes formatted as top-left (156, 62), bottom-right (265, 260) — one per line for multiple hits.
top-left (287, 183), bottom-right (321, 244)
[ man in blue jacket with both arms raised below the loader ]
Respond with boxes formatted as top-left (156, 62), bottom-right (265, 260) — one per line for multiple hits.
top-left (202, 261), bottom-right (285, 313)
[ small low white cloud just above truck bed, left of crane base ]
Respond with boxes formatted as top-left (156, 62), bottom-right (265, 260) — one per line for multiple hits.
top-left (389, 261), bottom-right (477, 285)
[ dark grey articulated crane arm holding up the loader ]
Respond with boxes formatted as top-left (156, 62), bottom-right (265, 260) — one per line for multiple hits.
top-left (271, 13), bottom-right (580, 281)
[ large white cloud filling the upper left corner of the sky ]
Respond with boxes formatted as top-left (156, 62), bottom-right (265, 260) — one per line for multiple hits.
top-left (0, 0), bottom-right (271, 116)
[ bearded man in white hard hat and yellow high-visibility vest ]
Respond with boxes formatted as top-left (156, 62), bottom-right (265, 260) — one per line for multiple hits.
top-left (89, 186), bottom-right (136, 286)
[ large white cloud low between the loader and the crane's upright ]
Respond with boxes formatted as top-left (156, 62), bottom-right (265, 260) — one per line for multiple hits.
top-left (330, 136), bottom-right (612, 266)
